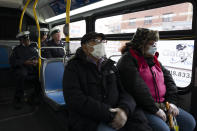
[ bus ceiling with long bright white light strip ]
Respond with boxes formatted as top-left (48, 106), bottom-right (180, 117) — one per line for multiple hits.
top-left (0, 0), bottom-right (147, 23)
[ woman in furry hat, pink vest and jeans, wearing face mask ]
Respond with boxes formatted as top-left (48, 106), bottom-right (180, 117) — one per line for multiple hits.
top-left (117, 28), bottom-right (196, 131)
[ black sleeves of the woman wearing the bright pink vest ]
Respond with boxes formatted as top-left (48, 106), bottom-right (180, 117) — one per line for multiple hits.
top-left (117, 51), bottom-right (177, 114)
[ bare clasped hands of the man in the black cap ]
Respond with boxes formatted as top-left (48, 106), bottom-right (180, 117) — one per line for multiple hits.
top-left (110, 108), bottom-right (127, 130)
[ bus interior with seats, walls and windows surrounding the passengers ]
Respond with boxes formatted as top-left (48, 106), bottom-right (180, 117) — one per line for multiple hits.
top-left (0, 0), bottom-right (197, 131)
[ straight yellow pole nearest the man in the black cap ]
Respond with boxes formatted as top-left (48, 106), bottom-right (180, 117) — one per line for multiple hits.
top-left (64, 0), bottom-right (71, 55)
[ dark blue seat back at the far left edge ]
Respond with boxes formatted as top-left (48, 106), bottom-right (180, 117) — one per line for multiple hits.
top-left (0, 45), bottom-right (10, 69)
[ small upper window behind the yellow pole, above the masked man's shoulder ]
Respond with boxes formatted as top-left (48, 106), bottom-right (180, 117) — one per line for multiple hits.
top-left (56, 20), bottom-right (86, 38)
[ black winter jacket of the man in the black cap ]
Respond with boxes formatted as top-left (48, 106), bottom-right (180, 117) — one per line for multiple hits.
top-left (63, 48), bottom-right (151, 131)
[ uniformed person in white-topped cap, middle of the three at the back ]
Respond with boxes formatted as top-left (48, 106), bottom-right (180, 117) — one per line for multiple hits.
top-left (40, 28), bottom-right (49, 58)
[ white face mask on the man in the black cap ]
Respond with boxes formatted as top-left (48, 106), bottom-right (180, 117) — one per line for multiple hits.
top-left (91, 43), bottom-right (106, 59)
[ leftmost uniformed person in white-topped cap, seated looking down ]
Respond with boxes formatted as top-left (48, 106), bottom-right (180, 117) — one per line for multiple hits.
top-left (10, 31), bottom-right (39, 109)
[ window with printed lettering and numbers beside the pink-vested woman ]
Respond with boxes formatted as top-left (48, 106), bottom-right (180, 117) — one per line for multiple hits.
top-left (157, 40), bottom-right (194, 88)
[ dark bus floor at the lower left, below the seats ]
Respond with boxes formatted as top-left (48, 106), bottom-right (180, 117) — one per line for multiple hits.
top-left (0, 102), bottom-right (67, 131)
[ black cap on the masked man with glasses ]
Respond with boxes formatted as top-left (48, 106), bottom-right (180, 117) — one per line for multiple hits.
top-left (81, 32), bottom-right (105, 45)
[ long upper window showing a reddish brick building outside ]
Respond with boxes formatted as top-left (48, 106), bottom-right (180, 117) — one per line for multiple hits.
top-left (95, 3), bottom-right (193, 34)
